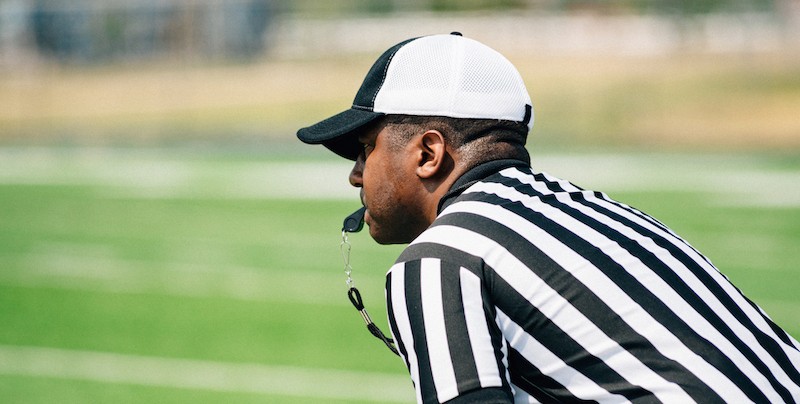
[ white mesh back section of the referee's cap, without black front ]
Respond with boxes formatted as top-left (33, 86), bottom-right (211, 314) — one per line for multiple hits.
top-left (373, 34), bottom-right (533, 129)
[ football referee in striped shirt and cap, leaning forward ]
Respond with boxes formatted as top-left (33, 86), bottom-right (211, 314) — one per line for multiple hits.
top-left (298, 33), bottom-right (800, 403)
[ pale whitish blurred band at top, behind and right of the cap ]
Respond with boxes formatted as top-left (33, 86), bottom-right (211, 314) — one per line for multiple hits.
top-left (272, 7), bottom-right (800, 56)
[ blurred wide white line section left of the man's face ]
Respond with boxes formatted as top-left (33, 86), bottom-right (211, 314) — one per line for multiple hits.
top-left (0, 148), bottom-right (358, 200)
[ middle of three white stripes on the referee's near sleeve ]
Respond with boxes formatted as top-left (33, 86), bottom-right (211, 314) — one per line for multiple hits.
top-left (418, 258), bottom-right (458, 402)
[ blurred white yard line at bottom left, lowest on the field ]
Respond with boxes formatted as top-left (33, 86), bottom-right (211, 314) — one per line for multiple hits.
top-left (0, 345), bottom-right (414, 403)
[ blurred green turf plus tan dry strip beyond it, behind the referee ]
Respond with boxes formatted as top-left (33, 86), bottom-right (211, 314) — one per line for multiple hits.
top-left (0, 11), bottom-right (800, 404)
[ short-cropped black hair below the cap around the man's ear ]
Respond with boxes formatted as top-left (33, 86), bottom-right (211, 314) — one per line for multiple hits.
top-left (381, 115), bottom-right (530, 166)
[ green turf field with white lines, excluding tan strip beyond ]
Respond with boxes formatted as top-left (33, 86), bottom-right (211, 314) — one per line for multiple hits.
top-left (0, 148), bottom-right (800, 403)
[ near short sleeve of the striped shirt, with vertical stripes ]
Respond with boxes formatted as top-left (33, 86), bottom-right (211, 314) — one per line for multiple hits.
top-left (386, 258), bottom-right (512, 403)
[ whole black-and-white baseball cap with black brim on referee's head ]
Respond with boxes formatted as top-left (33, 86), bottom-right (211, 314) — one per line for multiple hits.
top-left (297, 33), bottom-right (533, 160)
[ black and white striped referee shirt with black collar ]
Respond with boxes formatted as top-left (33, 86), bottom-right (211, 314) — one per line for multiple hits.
top-left (386, 161), bottom-right (800, 403)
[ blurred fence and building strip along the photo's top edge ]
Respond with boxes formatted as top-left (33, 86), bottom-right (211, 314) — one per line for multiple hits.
top-left (0, 0), bottom-right (800, 67)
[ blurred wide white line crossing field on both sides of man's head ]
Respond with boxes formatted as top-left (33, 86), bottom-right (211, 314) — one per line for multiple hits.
top-left (0, 148), bottom-right (800, 207)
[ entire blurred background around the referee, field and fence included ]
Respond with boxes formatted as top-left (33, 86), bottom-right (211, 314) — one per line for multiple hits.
top-left (0, 0), bottom-right (800, 403)
